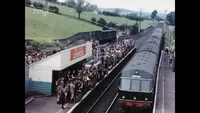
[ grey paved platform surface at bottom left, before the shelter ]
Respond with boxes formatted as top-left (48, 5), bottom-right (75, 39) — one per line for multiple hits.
top-left (25, 97), bottom-right (75, 113)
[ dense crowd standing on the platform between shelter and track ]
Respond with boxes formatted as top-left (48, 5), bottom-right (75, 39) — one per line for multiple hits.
top-left (56, 40), bottom-right (134, 107)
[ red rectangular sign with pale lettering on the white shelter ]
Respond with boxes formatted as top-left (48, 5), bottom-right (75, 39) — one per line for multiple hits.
top-left (70, 46), bottom-right (86, 61)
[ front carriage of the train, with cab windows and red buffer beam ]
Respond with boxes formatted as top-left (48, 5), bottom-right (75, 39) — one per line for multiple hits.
top-left (118, 51), bottom-right (157, 109)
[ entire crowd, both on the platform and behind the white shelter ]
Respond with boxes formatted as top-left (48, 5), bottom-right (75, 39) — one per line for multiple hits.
top-left (25, 39), bottom-right (134, 108)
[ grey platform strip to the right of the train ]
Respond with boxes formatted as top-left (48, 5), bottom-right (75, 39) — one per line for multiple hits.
top-left (155, 54), bottom-right (175, 113)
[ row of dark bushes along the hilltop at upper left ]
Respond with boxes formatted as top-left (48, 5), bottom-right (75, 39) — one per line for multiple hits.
top-left (25, 0), bottom-right (59, 14)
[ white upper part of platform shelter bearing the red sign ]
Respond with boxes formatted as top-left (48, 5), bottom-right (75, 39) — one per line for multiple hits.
top-left (29, 42), bottom-right (92, 70)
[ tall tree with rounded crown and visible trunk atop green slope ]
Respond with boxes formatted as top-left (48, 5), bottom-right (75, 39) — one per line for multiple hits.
top-left (75, 0), bottom-right (89, 19)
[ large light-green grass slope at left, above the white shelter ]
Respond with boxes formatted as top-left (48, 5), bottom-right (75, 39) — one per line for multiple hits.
top-left (25, 7), bottom-right (102, 39)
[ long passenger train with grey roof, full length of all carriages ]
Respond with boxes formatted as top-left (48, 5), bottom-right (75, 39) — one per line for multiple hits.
top-left (118, 26), bottom-right (164, 112)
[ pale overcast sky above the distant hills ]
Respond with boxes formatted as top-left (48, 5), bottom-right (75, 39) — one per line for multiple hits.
top-left (58, 0), bottom-right (175, 13)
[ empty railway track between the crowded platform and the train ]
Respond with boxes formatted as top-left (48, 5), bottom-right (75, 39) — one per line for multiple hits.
top-left (87, 30), bottom-right (153, 113)
